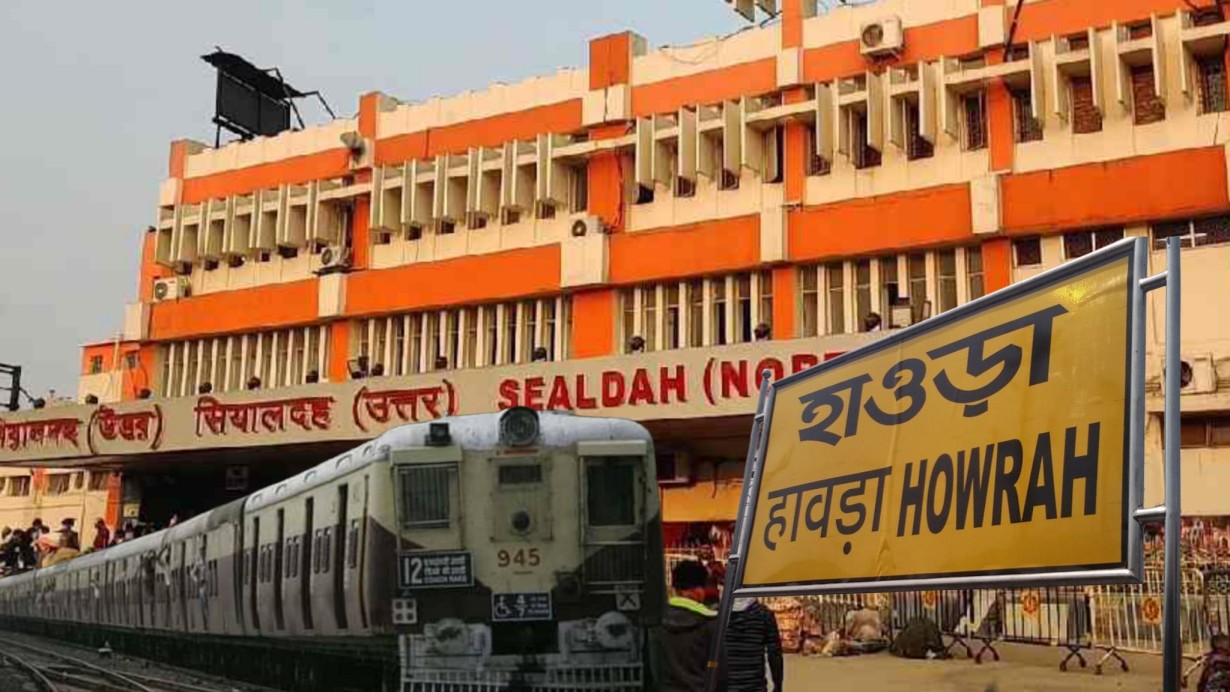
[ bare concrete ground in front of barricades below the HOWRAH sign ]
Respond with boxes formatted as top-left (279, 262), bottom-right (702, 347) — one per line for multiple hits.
top-left (784, 645), bottom-right (1175, 692)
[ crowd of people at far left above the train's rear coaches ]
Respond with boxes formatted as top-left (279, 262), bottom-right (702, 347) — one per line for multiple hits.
top-left (0, 517), bottom-right (176, 576)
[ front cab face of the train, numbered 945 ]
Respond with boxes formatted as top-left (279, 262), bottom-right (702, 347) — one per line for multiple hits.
top-left (389, 408), bottom-right (665, 690)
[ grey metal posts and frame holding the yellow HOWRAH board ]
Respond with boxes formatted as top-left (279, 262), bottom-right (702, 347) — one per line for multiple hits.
top-left (704, 237), bottom-right (1182, 692)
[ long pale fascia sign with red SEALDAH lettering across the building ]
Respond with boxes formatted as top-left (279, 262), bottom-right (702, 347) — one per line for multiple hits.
top-left (0, 334), bottom-right (882, 463)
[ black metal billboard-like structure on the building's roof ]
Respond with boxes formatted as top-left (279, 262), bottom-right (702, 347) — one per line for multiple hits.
top-left (200, 48), bottom-right (337, 146)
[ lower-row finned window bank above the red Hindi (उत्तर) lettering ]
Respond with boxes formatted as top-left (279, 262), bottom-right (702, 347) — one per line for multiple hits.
top-left (351, 296), bottom-right (572, 377)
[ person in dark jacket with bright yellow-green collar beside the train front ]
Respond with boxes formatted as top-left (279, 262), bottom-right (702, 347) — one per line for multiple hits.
top-left (661, 559), bottom-right (717, 692)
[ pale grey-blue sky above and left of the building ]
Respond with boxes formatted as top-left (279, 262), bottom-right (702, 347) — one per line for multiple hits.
top-left (0, 0), bottom-right (745, 396)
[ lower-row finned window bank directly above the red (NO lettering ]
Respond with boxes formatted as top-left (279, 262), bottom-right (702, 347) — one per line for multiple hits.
top-left (617, 272), bottom-right (772, 353)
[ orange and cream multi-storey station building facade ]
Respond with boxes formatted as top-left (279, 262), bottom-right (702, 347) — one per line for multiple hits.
top-left (7, 0), bottom-right (1230, 535)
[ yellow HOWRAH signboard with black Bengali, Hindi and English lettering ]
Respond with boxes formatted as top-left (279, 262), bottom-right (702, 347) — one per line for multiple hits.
top-left (740, 241), bottom-right (1141, 590)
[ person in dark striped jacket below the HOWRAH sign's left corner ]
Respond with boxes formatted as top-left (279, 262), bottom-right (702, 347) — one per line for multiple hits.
top-left (722, 599), bottom-right (784, 692)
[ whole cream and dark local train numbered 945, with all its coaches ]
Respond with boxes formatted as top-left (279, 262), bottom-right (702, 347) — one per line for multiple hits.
top-left (0, 408), bottom-right (665, 692)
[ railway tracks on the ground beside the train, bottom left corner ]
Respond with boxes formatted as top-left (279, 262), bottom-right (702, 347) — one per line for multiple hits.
top-left (0, 637), bottom-right (238, 692)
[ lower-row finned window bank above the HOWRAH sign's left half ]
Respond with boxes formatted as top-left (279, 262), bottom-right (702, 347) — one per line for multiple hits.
top-left (797, 247), bottom-right (986, 337)
